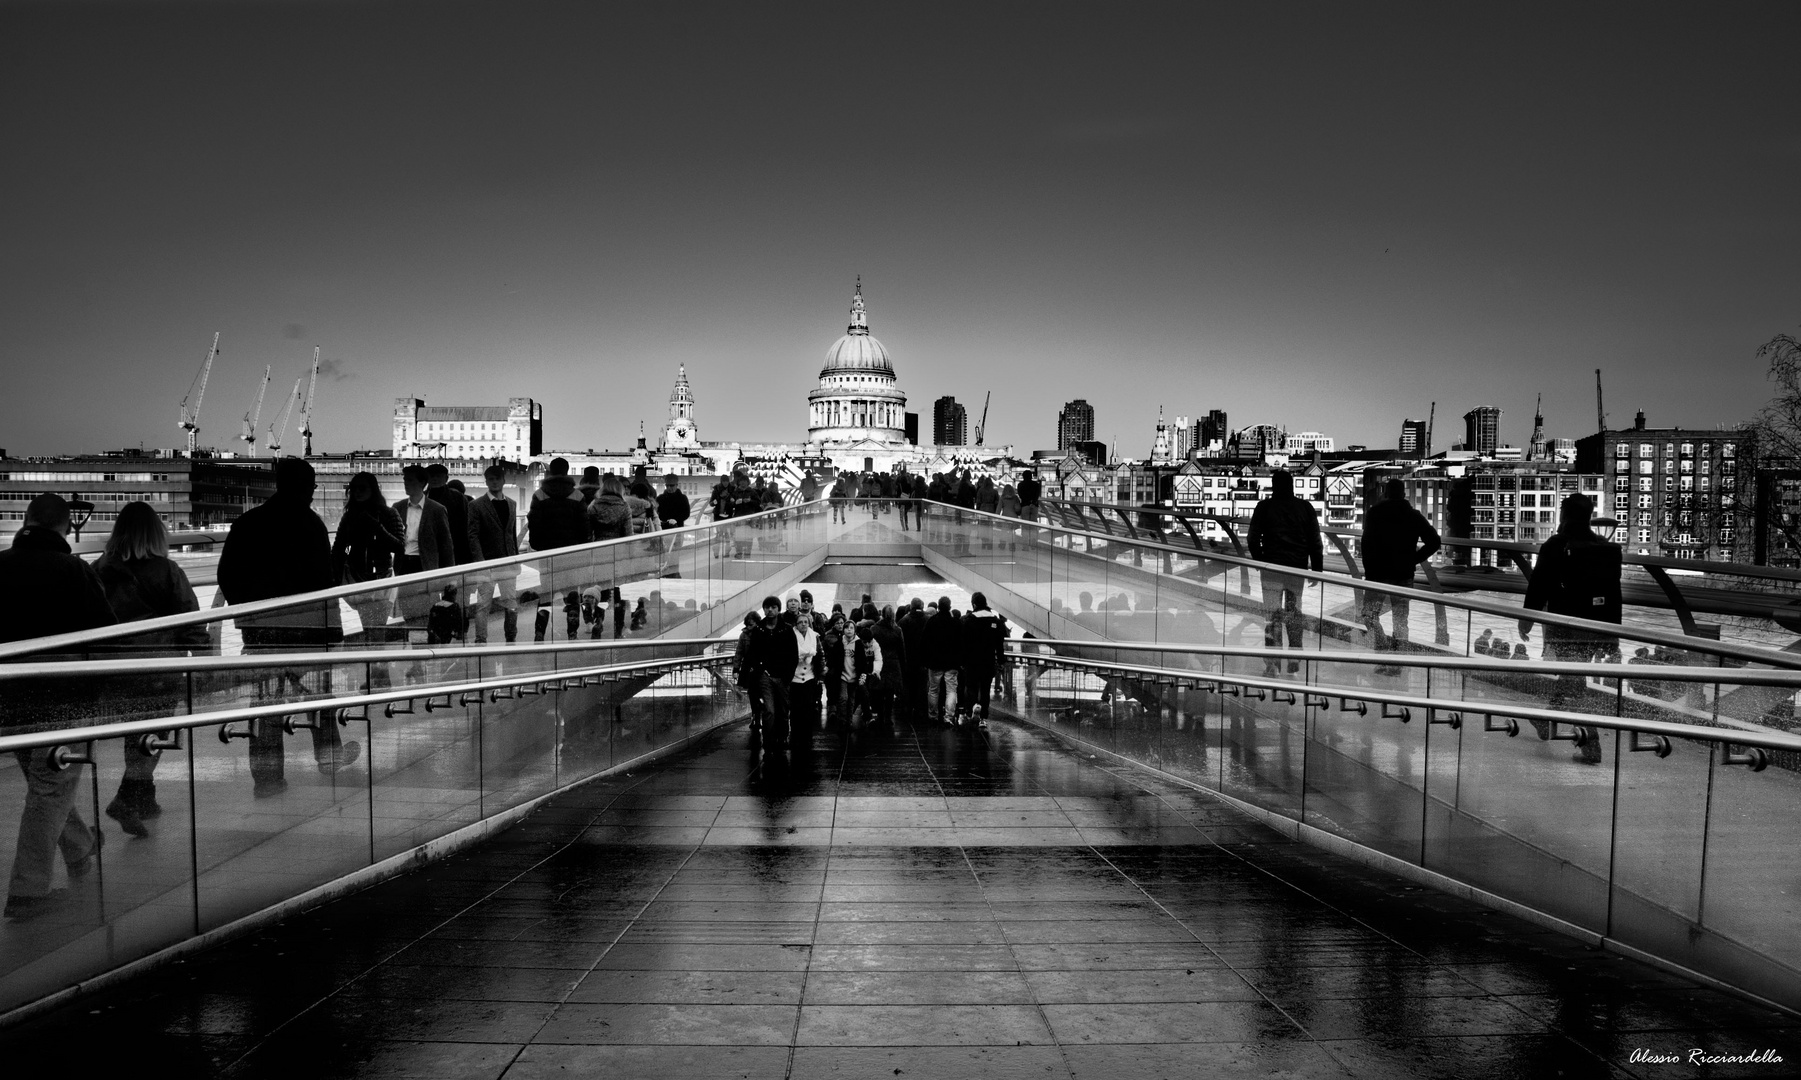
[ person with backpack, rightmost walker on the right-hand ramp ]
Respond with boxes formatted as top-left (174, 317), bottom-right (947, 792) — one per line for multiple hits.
top-left (1520, 495), bottom-right (1621, 765)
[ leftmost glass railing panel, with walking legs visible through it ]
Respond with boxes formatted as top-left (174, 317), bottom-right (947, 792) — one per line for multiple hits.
top-left (0, 738), bottom-right (195, 1012)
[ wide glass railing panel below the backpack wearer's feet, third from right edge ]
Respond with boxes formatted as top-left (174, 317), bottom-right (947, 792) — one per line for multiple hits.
top-left (1414, 715), bottom-right (1614, 931)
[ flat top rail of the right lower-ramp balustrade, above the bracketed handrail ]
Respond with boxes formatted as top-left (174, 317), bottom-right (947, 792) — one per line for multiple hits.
top-left (1007, 637), bottom-right (1801, 691)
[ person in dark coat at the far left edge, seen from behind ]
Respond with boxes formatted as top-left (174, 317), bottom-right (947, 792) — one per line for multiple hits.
top-left (0, 493), bottom-right (117, 920)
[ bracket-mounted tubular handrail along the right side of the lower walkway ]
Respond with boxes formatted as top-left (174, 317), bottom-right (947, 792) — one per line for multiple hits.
top-left (1032, 655), bottom-right (1801, 752)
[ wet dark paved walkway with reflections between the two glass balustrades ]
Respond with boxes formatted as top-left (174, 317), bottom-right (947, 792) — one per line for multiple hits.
top-left (0, 722), bottom-right (1801, 1080)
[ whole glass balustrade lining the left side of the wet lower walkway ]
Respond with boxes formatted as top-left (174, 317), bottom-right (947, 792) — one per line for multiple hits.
top-left (0, 650), bottom-right (746, 1012)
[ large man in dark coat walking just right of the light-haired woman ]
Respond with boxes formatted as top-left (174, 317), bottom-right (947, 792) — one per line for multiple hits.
top-left (218, 457), bottom-right (358, 797)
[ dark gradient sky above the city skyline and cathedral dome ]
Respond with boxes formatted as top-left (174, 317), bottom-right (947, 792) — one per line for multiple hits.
top-left (0, 0), bottom-right (1801, 455)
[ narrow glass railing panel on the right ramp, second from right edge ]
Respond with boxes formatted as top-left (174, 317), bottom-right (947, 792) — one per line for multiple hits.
top-left (1603, 733), bottom-right (1713, 956)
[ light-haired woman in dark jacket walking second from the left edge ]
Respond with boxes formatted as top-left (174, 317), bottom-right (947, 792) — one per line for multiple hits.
top-left (94, 502), bottom-right (209, 837)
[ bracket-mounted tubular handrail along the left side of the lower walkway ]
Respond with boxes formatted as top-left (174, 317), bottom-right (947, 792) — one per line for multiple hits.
top-left (0, 657), bottom-right (728, 752)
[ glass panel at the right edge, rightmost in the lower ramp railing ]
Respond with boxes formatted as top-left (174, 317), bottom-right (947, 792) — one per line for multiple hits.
top-left (1698, 743), bottom-right (1801, 992)
